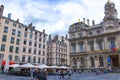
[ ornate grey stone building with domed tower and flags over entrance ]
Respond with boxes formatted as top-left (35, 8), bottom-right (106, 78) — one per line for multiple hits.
top-left (69, 1), bottom-right (120, 69)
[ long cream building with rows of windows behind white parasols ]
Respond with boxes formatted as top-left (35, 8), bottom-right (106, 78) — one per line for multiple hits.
top-left (0, 5), bottom-right (47, 65)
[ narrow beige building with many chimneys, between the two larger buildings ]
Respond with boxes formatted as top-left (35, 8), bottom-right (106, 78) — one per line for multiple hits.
top-left (47, 35), bottom-right (70, 66)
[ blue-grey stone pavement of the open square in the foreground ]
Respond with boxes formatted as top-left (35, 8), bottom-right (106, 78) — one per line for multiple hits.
top-left (0, 73), bottom-right (120, 80)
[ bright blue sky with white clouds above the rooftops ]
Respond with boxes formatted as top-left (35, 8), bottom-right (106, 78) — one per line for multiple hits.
top-left (0, 0), bottom-right (120, 35)
